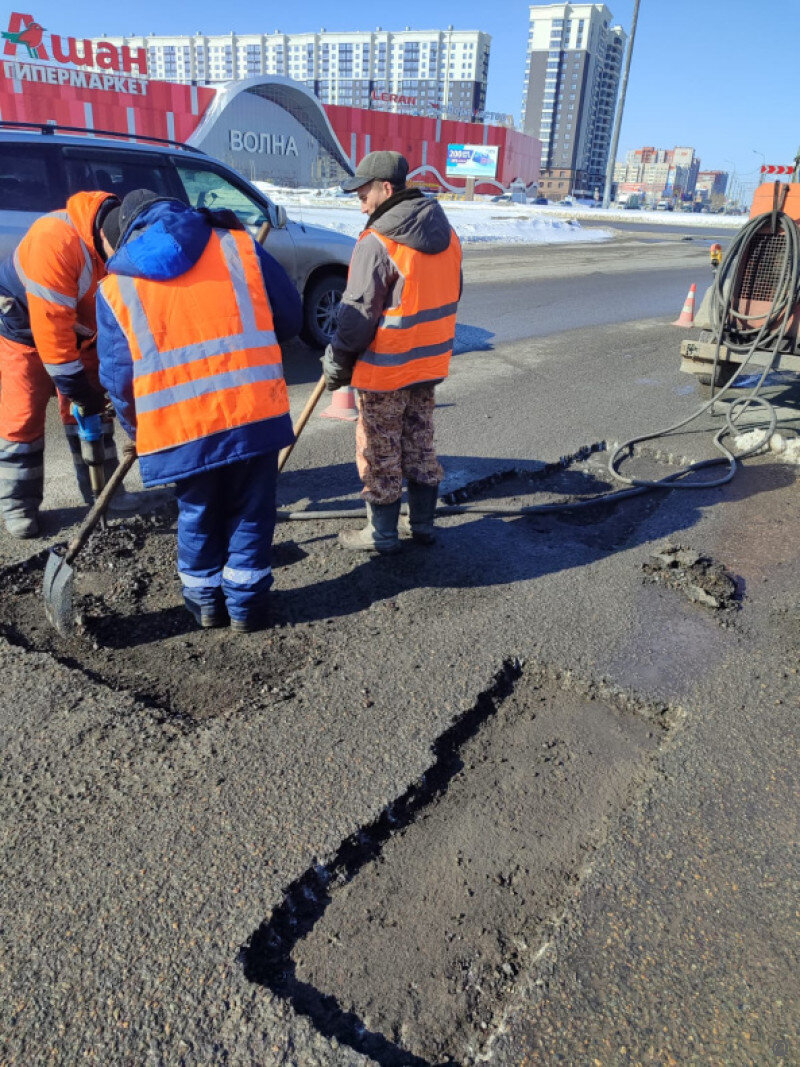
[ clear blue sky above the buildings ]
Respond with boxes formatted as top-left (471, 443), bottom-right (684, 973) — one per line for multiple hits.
top-left (14, 0), bottom-right (800, 189)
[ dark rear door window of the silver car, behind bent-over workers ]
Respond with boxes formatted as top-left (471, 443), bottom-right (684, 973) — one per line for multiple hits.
top-left (64, 146), bottom-right (178, 200)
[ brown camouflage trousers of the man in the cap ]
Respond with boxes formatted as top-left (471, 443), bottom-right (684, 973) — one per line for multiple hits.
top-left (355, 385), bottom-right (445, 504)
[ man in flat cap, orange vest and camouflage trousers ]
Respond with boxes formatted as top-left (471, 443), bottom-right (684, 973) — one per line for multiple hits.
top-left (322, 152), bottom-right (462, 554)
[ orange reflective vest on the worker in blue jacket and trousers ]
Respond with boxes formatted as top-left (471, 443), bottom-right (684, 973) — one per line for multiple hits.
top-left (101, 229), bottom-right (289, 456)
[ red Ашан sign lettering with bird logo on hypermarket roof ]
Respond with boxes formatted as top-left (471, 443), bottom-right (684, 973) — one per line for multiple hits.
top-left (0, 11), bottom-right (147, 74)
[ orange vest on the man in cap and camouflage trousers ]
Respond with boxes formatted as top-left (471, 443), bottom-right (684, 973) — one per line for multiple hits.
top-left (352, 228), bottom-right (461, 393)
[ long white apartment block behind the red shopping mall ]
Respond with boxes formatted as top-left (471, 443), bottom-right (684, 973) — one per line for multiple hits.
top-left (93, 27), bottom-right (492, 118)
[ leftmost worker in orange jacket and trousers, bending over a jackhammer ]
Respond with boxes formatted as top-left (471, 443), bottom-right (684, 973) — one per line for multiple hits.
top-left (0, 192), bottom-right (130, 538)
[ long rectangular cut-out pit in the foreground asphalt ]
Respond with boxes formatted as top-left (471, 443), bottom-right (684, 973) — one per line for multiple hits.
top-left (242, 663), bottom-right (678, 1067)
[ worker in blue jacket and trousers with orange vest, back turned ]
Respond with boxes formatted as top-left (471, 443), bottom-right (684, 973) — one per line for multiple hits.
top-left (97, 189), bottom-right (302, 633)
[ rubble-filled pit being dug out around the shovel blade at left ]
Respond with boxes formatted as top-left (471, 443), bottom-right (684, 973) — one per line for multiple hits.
top-left (0, 506), bottom-right (313, 720)
